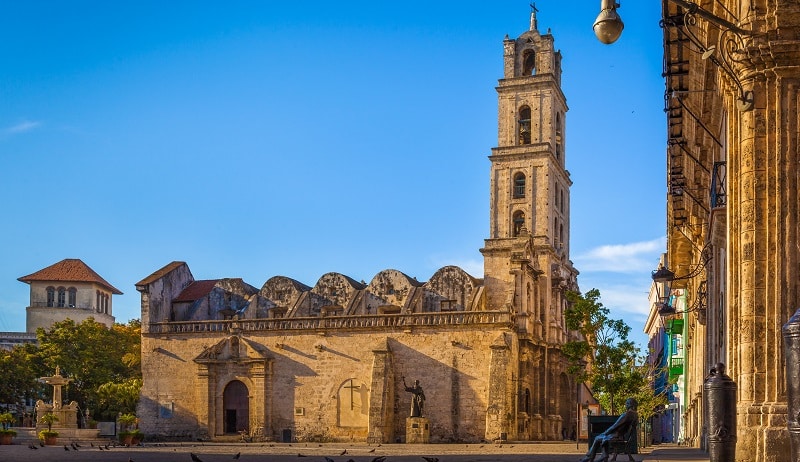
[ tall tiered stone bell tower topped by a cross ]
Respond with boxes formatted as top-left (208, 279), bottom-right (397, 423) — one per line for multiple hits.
top-left (481, 8), bottom-right (577, 344)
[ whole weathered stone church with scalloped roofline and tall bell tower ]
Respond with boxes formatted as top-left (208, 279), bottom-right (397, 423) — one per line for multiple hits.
top-left (136, 11), bottom-right (580, 443)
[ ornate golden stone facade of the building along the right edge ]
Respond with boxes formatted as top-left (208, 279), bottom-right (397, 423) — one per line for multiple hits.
top-left (662, 0), bottom-right (800, 462)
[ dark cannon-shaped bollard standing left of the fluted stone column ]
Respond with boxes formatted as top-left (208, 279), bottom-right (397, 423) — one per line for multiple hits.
top-left (703, 363), bottom-right (736, 462)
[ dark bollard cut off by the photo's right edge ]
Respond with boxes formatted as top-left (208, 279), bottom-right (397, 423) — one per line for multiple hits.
top-left (781, 309), bottom-right (800, 460)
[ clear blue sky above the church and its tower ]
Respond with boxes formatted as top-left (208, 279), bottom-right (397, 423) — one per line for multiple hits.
top-left (0, 0), bottom-right (666, 343)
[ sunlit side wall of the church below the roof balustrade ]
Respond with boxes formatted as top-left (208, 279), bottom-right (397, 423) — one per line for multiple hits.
top-left (138, 326), bottom-right (514, 442)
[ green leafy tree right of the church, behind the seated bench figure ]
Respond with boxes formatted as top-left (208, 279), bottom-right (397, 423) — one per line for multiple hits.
top-left (562, 289), bottom-right (649, 414)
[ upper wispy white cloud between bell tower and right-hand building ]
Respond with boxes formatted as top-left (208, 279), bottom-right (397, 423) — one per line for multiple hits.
top-left (573, 237), bottom-right (666, 273)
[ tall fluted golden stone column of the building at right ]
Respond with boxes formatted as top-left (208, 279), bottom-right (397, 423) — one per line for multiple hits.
top-left (728, 40), bottom-right (800, 462)
